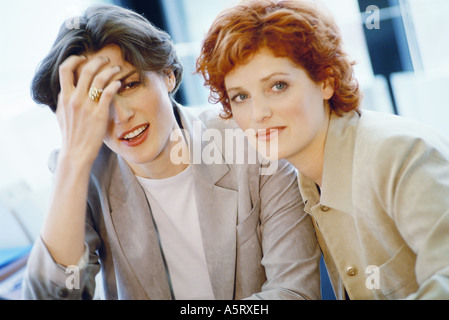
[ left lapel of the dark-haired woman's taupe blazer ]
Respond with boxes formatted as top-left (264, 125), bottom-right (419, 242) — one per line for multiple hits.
top-left (109, 156), bottom-right (171, 299)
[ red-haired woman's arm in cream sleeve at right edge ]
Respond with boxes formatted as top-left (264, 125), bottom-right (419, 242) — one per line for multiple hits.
top-left (372, 134), bottom-right (449, 299)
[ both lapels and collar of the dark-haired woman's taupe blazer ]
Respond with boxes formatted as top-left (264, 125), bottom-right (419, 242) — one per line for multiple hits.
top-left (109, 106), bottom-right (237, 299)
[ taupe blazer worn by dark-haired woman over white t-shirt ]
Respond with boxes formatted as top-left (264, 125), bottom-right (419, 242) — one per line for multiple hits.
top-left (23, 106), bottom-right (320, 299)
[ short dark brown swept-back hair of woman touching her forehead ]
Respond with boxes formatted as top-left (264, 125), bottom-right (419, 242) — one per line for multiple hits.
top-left (31, 4), bottom-right (183, 112)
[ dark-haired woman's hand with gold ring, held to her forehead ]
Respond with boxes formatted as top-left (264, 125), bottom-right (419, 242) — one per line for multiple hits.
top-left (56, 56), bottom-right (121, 163)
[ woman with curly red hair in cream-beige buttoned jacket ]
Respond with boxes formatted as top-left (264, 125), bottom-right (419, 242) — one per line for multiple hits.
top-left (197, 0), bottom-right (449, 299)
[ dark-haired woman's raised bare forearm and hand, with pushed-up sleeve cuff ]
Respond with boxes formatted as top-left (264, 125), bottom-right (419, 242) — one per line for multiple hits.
top-left (24, 56), bottom-right (120, 298)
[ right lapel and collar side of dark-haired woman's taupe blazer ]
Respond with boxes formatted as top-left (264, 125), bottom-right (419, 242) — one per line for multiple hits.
top-left (178, 108), bottom-right (238, 300)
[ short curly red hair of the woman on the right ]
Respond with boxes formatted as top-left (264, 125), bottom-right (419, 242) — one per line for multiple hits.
top-left (196, 0), bottom-right (361, 118)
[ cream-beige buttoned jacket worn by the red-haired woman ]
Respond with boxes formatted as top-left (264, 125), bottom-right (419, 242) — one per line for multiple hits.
top-left (299, 110), bottom-right (449, 299)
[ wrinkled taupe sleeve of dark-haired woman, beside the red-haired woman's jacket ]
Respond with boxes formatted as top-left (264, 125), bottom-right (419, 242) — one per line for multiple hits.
top-left (247, 161), bottom-right (320, 299)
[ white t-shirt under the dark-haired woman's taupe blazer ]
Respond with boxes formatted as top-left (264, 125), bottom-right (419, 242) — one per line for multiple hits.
top-left (137, 166), bottom-right (214, 300)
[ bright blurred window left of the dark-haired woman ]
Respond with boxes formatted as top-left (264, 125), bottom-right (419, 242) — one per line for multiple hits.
top-left (0, 0), bottom-right (108, 250)
